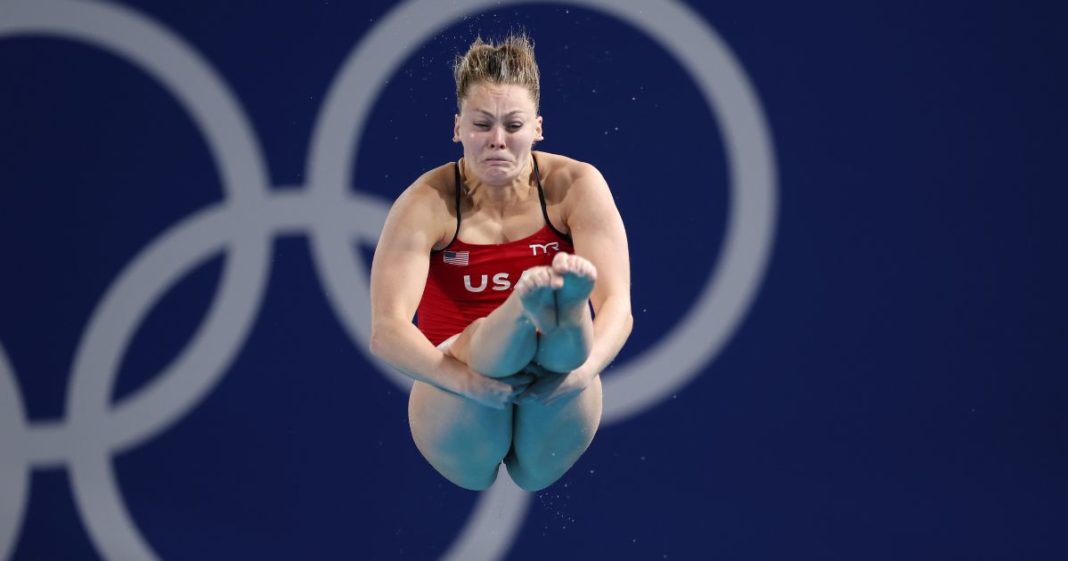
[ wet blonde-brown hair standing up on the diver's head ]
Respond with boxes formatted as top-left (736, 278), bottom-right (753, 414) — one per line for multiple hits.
top-left (453, 34), bottom-right (541, 113)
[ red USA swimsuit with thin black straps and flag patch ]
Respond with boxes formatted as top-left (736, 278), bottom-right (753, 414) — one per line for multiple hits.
top-left (417, 160), bottom-right (575, 345)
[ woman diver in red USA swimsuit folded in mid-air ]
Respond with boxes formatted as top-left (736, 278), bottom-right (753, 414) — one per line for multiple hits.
top-left (371, 36), bottom-right (633, 490)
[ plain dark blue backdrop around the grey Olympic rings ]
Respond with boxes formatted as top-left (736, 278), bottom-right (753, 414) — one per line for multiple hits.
top-left (0, 0), bottom-right (1068, 560)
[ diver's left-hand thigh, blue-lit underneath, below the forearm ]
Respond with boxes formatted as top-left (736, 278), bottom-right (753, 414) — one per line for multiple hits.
top-left (408, 335), bottom-right (513, 489)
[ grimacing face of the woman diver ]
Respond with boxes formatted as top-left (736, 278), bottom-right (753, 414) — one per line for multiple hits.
top-left (453, 82), bottom-right (541, 185)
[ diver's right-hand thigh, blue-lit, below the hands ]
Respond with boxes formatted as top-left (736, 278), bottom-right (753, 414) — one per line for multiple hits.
top-left (508, 376), bottom-right (602, 490)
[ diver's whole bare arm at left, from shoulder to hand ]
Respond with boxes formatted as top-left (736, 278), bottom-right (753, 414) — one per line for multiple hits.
top-left (371, 182), bottom-right (529, 408)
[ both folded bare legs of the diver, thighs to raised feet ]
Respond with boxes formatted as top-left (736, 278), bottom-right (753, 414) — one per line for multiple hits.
top-left (408, 255), bottom-right (601, 489)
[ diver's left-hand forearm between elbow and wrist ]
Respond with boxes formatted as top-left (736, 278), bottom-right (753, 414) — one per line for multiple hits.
top-left (371, 320), bottom-right (468, 392)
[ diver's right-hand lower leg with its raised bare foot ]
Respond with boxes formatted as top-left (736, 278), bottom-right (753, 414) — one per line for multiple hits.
top-left (534, 252), bottom-right (597, 372)
